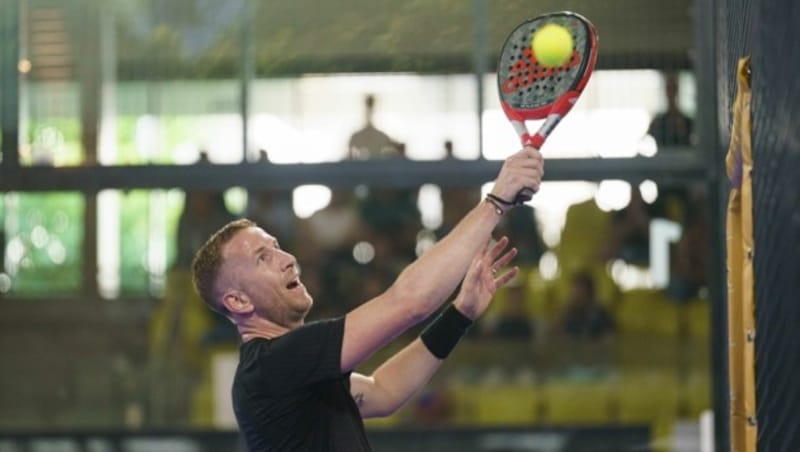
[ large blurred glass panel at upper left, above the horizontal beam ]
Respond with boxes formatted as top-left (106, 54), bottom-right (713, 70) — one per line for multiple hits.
top-left (20, 0), bottom-right (243, 166)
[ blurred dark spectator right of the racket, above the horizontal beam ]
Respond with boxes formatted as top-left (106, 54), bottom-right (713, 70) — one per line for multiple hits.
top-left (648, 72), bottom-right (694, 147)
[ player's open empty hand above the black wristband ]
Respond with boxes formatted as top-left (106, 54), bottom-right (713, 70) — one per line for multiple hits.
top-left (453, 237), bottom-right (519, 320)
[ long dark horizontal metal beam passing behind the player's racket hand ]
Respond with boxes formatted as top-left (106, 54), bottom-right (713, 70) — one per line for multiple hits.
top-left (0, 153), bottom-right (706, 191)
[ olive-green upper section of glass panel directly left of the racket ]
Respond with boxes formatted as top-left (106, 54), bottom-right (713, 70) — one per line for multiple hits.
top-left (250, 0), bottom-right (473, 75)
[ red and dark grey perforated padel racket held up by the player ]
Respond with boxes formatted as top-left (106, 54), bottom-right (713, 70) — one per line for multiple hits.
top-left (497, 11), bottom-right (597, 204)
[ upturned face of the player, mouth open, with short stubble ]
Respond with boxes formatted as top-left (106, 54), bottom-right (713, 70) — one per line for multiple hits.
top-left (219, 226), bottom-right (313, 327)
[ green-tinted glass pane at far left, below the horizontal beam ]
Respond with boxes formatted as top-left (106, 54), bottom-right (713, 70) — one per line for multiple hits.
top-left (4, 193), bottom-right (84, 297)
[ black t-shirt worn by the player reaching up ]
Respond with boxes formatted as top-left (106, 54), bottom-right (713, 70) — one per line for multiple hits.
top-left (232, 318), bottom-right (371, 452)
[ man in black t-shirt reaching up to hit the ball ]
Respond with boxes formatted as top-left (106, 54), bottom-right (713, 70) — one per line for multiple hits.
top-left (192, 148), bottom-right (543, 452)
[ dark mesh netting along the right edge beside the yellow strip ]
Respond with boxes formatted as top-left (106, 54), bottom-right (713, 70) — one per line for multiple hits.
top-left (717, 0), bottom-right (800, 452)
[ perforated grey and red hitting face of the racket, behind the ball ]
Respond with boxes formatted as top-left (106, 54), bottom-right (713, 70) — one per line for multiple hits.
top-left (497, 13), bottom-right (594, 119)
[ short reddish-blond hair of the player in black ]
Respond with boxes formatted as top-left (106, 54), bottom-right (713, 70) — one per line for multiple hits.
top-left (192, 218), bottom-right (256, 316)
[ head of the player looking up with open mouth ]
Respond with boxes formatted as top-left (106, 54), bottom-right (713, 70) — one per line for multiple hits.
top-left (192, 220), bottom-right (312, 328)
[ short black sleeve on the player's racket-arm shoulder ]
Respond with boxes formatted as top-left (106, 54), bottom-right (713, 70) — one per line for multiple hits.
top-left (257, 317), bottom-right (344, 395)
